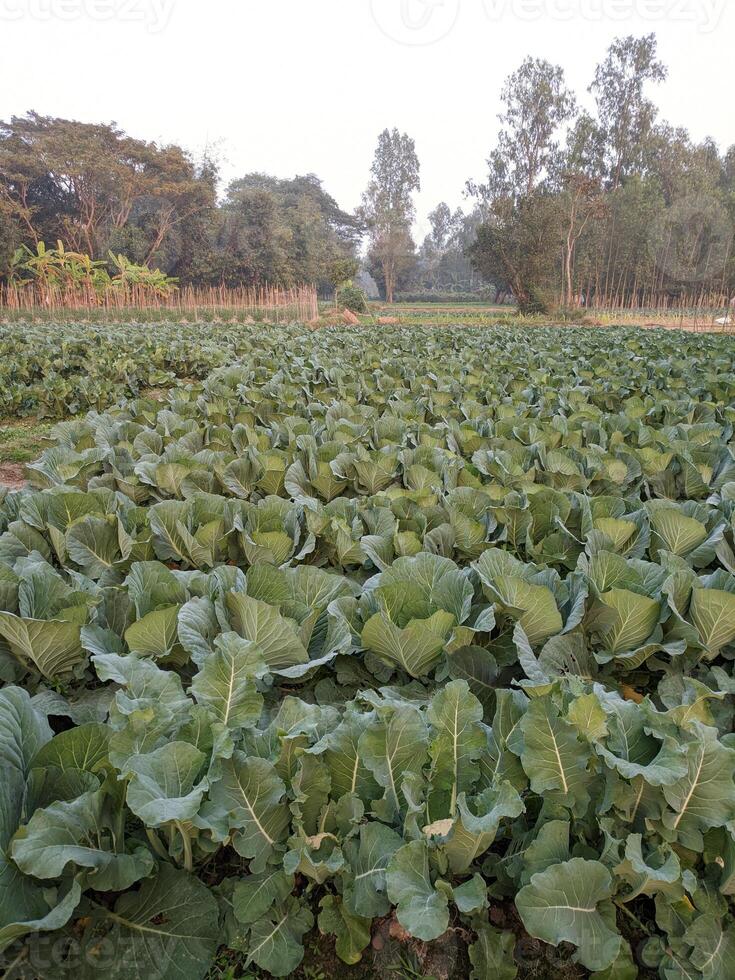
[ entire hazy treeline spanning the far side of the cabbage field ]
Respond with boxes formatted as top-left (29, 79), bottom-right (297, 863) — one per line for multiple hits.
top-left (0, 35), bottom-right (735, 310)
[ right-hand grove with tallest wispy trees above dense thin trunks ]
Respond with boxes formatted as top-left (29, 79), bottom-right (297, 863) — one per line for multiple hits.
top-left (468, 35), bottom-right (735, 309)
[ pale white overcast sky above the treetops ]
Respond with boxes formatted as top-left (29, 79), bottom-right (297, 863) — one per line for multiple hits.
top-left (0, 0), bottom-right (735, 233)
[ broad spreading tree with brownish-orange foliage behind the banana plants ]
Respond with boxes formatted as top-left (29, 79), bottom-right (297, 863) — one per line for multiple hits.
top-left (0, 112), bottom-right (215, 263)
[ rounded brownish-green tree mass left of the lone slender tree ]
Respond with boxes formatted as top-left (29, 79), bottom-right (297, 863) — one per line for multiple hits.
top-left (0, 113), bottom-right (359, 286)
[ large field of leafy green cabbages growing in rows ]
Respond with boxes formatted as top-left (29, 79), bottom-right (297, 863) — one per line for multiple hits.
top-left (0, 325), bottom-right (735, 980)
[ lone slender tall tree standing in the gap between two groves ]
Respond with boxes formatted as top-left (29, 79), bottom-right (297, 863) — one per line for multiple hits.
top-left (360, 129), bottom-right (421, 303)
